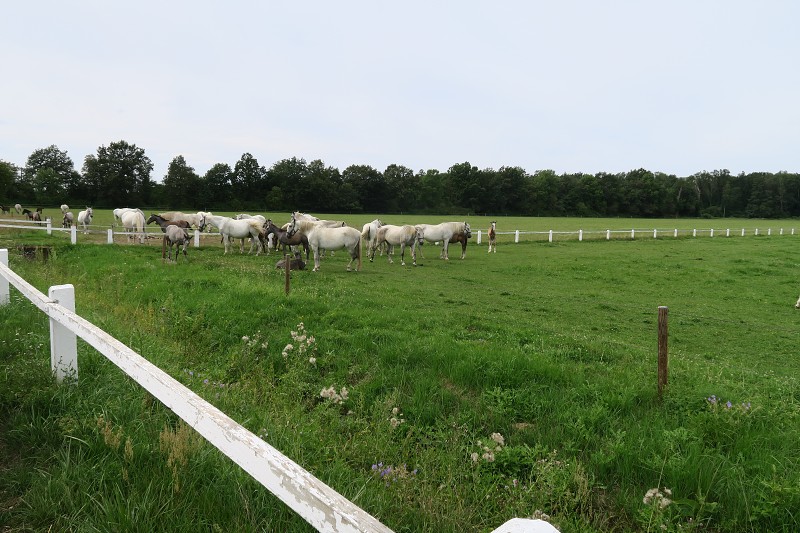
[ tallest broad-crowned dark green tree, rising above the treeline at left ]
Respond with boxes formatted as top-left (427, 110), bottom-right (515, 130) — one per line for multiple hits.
top-left (82, 141), bottom-right (153, 207)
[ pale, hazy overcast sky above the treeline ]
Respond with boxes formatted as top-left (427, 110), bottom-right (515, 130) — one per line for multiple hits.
top-left (0, 0), bottom-right (800, 181)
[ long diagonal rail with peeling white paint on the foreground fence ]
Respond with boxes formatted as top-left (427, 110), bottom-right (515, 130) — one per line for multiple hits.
top-left (0, 251), bottom-right (391, 533)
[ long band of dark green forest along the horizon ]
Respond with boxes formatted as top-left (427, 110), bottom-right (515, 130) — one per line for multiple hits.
top-left (0, 141), bottom-right (800, 218)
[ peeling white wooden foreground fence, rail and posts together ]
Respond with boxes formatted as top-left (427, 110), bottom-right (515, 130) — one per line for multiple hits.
top-left (0, 249), bottom-right (556, 533)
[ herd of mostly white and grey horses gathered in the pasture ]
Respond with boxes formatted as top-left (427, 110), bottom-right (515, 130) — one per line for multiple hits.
top-left (4, 204), bottom-right (497, 272)
